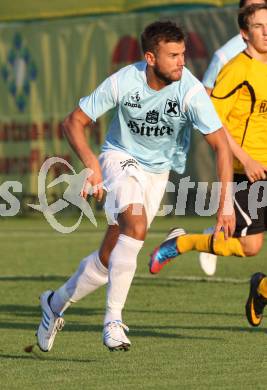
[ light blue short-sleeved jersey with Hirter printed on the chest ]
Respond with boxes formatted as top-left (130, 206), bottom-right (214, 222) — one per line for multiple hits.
top-left (79, 62), bottom-right (222, 173)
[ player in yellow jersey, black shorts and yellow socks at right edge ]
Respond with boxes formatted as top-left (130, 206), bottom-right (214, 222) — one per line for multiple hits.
top-left (150, 4), bottom-right (267, 326)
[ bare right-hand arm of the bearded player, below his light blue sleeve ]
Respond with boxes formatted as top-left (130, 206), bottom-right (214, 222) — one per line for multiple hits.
top-left (205, 128), bottom-right (235, 239)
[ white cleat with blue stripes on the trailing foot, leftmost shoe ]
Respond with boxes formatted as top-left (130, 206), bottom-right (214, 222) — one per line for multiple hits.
top-left (36, 290), bottom-right (64, 352)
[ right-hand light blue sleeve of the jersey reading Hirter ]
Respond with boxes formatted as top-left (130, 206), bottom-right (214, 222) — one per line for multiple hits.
top-left (184, 83), bottom-right (222, 135)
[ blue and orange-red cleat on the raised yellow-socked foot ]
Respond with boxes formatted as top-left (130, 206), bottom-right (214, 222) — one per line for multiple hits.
top-left (149, 228), bottom-right (186, 274)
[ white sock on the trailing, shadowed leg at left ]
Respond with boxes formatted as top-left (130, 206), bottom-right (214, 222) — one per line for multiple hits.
top-left (50, 251), bottom-right (108, 314)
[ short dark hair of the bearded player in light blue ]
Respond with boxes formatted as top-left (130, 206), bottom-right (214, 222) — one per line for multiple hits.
top-left (141, 21), bottom-right (185, 53)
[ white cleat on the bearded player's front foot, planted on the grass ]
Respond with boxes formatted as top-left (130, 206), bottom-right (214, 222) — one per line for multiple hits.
top-left (103, 320), bottom-right (131, 351)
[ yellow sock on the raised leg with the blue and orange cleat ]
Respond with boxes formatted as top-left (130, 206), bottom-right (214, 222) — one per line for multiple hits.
top-left (177, 232), bottom-right (245, 257)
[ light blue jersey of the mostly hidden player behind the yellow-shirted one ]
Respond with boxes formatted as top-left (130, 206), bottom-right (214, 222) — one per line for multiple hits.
top-left (202, 34), bottom-right (247, 89)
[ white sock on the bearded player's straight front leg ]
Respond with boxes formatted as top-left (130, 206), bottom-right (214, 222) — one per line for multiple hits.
top-left (104, 234), bottom-right (144, 324)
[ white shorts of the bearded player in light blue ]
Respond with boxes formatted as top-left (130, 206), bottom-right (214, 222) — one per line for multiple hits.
top-left (99, 150), bottom-right (169, 228)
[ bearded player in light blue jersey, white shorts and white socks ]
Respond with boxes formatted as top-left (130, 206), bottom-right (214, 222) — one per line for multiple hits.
top-left (37, 22), bottom-right (235, 351)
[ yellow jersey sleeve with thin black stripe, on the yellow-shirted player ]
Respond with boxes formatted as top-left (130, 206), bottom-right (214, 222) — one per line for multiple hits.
top-left (211, 56), bottom-right (246, 123)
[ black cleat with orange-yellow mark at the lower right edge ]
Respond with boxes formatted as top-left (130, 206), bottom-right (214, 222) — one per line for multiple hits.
top-left (246, 272), bottom-right (267, 326)
